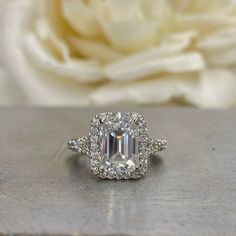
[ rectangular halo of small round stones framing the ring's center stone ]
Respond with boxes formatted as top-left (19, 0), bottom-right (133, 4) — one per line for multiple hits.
top-left (89, 112), bottom-right (149, 179)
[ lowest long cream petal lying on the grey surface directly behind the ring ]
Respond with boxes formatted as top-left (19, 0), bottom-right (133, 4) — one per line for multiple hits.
top-left (91, 74), bottom-right (196, 105)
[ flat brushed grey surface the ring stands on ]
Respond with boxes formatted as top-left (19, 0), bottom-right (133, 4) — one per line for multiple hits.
top-left (0, 108), bottom-right (236, 236)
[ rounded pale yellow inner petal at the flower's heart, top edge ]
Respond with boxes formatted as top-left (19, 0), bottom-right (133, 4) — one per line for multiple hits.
top-left (97, 0), bottom-right (172, 51)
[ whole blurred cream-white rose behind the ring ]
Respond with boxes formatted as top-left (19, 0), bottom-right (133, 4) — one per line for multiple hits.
top-left (1, 0), bottom-right (236, 107)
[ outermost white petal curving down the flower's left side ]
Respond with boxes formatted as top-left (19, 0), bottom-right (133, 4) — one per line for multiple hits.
top-left (1, 0), bottom-right (92, 106)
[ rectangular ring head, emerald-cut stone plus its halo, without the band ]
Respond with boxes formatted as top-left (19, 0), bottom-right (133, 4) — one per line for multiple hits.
top-left (90, 112), bottom-right (147, 179)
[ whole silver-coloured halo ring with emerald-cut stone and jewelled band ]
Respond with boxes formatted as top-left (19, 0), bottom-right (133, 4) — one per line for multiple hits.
top-left (68, 112), bottom-right (167, 179)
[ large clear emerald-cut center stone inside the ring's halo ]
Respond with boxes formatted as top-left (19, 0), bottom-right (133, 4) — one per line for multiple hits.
top-left (100, 127), bottom-right (138, 173)
